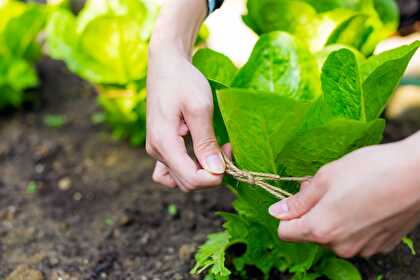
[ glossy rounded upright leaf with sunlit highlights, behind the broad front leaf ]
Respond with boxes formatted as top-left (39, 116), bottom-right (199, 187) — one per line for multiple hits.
top-left (232, 32), bottom-right (320, 100)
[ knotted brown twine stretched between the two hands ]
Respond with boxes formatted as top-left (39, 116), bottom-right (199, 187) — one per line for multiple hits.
top-left (223, 154), bottom-right (311, 199)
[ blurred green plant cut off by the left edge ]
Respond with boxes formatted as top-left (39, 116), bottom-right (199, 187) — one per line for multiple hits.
top-left (0, 0), bottom-right (46, 110)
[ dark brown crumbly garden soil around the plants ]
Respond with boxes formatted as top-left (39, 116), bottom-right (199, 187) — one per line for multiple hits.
top-left (0, 59), bottom-right (420, 280)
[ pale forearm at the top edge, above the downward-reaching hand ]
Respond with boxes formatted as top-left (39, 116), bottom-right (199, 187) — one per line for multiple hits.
top-left (150, 0), bottom-right (208, 59)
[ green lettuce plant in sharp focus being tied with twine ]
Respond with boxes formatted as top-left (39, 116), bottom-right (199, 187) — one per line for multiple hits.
top-left (192, 26), bottom-right (420, 280)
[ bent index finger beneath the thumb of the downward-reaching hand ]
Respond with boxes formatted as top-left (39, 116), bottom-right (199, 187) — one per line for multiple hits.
top-left (160, 130), bottom-right (223, 191)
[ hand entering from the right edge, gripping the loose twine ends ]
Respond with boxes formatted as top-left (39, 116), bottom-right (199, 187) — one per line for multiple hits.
top-left (269, 136), bottom-right (420, 258)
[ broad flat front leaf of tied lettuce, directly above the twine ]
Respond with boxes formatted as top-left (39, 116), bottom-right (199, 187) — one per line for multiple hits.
top-left (217, 89), bottom-right (310, 172)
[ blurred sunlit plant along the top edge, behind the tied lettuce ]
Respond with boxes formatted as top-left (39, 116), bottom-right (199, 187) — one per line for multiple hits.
top-left (244, 0), bottom-right (399, 55)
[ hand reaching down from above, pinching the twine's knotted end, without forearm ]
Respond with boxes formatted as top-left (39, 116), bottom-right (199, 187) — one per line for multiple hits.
top-left (146, 52), bottom-right (225, 191)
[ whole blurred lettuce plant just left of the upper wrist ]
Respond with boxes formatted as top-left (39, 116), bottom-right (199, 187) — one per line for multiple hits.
top-left (47, 0), bottom-right (157, 145)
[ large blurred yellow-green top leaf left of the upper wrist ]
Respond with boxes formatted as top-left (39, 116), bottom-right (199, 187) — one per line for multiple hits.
top-left (46, 0), bottom-right (157, 85)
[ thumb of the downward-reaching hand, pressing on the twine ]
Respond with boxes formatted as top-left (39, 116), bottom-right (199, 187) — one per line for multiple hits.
top-left (184, 101), bottom-right (226, 174)
